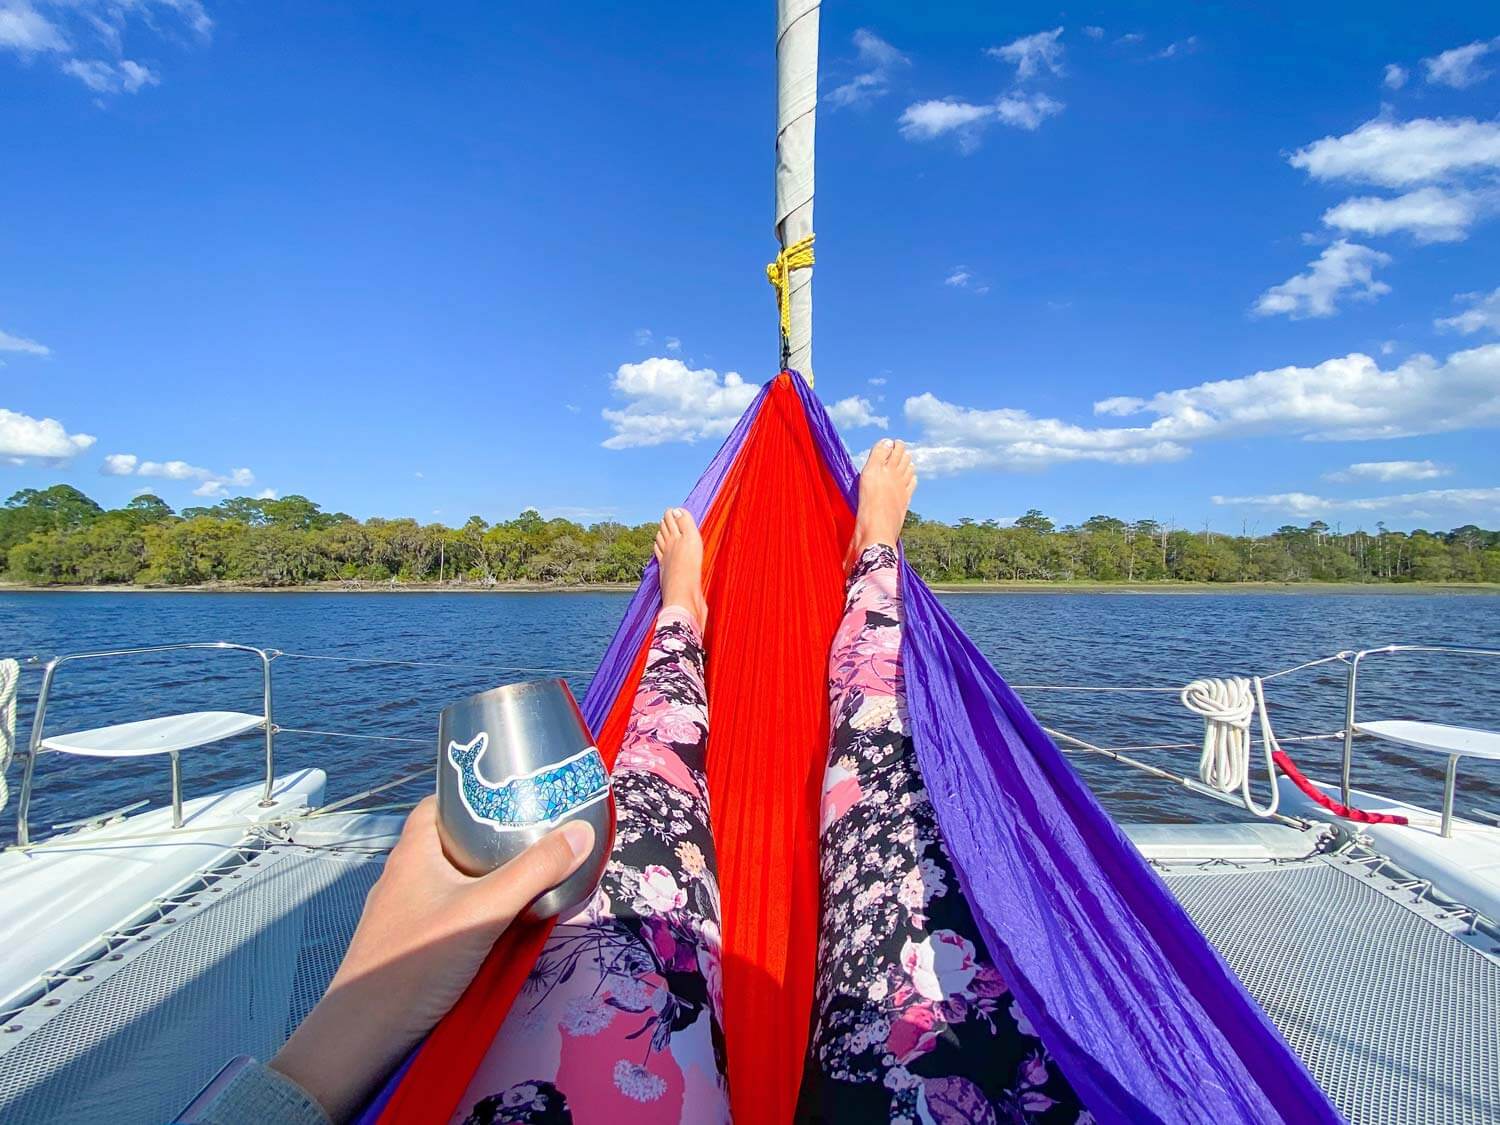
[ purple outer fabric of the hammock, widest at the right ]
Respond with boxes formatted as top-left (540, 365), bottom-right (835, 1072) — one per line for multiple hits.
top-left (584, 372), bottom-right (1343, 1125)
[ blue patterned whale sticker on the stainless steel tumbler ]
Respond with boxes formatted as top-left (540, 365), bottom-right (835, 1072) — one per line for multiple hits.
top-left (449, 731), bottom-right (609, 831)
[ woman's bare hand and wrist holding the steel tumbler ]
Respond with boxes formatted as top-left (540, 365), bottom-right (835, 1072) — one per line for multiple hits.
top-left (270, 797), bottom-right (594, 1122)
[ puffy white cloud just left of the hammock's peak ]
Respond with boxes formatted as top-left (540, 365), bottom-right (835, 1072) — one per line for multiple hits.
top-left (602, 356), bottom-right (756, 449)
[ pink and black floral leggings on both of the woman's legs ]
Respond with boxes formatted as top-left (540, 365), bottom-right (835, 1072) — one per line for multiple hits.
top-left (453, 545), bottom-right (1092, 1125)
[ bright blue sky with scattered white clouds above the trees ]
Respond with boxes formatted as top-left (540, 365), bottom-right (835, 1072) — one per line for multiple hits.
top-left (0, 0), bottom-right (1500, 531)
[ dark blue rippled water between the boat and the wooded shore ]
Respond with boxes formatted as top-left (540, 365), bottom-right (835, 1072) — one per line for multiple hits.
top-left (0, 593), bottom-right (1500, 839)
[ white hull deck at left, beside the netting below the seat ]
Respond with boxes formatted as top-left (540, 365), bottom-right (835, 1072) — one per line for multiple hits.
top-left (0, 770), bottom-right (327, 1008)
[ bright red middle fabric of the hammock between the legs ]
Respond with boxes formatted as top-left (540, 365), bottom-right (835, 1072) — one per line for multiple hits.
top-left (378, 374), bottom-right (854, 1125)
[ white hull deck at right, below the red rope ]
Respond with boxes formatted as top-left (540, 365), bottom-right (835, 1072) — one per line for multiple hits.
top-left (1278, 774), bottom-right (1500, 920)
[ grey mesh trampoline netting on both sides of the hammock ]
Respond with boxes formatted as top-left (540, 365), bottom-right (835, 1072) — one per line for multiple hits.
top-left (0, 816), bottom-right (1500, 1125)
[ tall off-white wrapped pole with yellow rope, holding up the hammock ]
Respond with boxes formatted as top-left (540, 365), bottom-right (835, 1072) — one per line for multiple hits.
top-left (776, 0), bottom-right (821, 383)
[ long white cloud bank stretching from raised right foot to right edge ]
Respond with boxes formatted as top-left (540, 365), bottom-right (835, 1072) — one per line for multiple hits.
top-left (905, 344), bottom-right (1500, 473)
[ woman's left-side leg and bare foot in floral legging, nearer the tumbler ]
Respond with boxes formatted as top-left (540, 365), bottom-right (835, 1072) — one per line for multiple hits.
top-left (456, 512), bottom-right (729, 1125)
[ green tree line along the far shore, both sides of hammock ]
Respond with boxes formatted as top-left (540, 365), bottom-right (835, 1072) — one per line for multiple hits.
top-left (0, 485), bottom-right (1500, 587)
